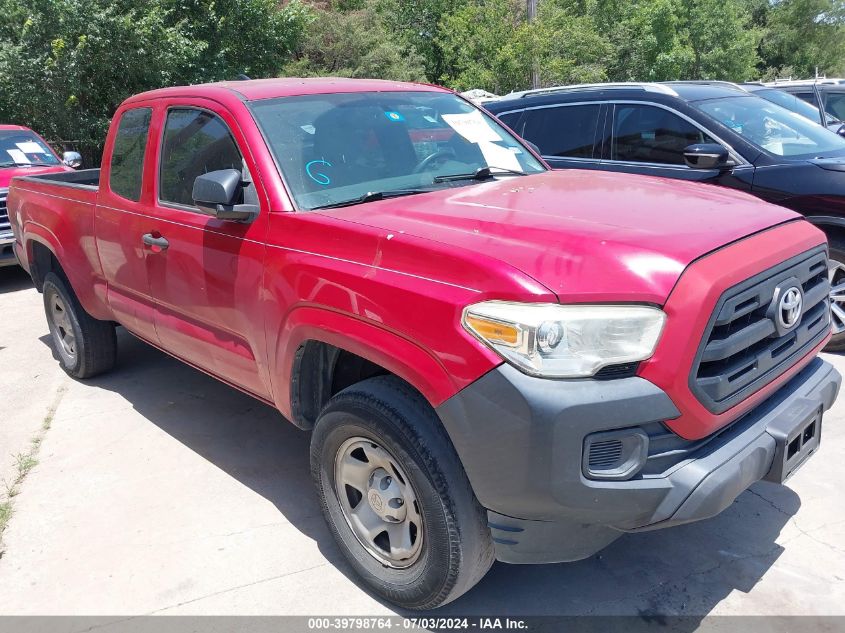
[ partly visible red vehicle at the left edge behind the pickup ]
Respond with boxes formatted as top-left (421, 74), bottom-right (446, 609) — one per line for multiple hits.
top-left (0, 125), bottom-right (81, 266)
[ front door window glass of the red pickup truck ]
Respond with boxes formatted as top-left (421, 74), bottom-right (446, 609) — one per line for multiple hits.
top-left (159, 108), bottom-right (243, 207)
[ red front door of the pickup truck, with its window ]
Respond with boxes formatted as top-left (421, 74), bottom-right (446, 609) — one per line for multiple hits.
top-left (147, 100), bottom-right (271, 399)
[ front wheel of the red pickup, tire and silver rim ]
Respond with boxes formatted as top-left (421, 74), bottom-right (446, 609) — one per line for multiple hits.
top-left (311, 376), bottom-right (494, 609)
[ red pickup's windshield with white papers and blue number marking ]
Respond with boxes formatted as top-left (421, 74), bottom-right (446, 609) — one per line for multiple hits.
top-left (249, 92), bottom-right (545, 209)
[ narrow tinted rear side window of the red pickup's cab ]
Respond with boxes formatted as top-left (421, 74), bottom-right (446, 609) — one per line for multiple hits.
top-left (109, 108), bottom-right (153, 202)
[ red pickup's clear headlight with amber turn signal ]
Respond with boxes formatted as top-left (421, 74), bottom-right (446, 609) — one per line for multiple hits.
top-left (463, 301), bottom-right (666, 378)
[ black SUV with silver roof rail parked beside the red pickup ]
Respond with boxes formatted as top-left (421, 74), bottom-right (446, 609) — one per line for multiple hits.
top-left (485, 81), bottom-right (845, 350)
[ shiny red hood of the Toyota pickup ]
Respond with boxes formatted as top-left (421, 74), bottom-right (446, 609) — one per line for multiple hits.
top-left (319, 170), bottom-right (800, 304)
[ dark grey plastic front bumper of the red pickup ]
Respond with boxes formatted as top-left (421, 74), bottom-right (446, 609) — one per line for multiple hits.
top-left (437, 358), bottom-right (841, 563)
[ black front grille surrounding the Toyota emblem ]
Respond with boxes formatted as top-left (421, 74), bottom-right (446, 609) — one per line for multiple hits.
top-left (690, 247), bottom-right (830, 414)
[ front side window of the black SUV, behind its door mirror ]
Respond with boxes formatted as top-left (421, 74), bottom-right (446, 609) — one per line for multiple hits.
top-left (611, 104), bottom-right (716, 165)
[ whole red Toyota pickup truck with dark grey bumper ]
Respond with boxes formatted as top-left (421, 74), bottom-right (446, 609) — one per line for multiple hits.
top-left (3, 79), bottom-right (840, 609)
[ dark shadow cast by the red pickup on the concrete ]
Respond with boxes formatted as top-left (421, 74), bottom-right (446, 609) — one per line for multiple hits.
top-left (41, 330), bottom-right (800, 630)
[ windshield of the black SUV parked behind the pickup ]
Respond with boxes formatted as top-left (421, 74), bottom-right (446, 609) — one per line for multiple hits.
top-left (695, 95), bottom-right (845, 158)
